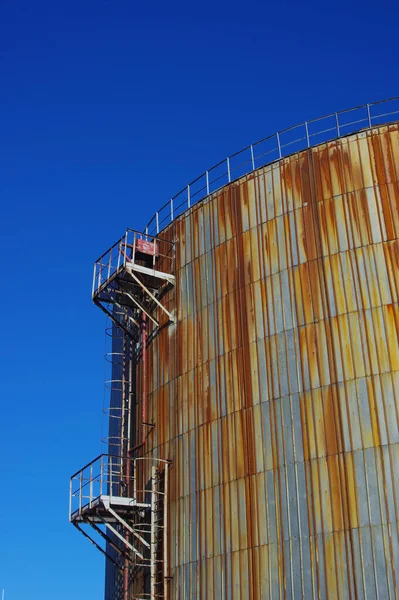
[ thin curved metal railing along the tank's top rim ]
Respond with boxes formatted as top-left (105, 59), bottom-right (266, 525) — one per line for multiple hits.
top-left (145, 96), bottom-right (399, 236)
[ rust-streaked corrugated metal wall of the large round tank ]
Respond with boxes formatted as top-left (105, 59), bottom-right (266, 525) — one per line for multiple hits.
top-left (137, 124), bottom-right (399, 600)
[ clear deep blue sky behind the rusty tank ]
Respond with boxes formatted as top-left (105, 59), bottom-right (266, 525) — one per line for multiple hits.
top-left (0, 0), bottom-right (399, 600)
